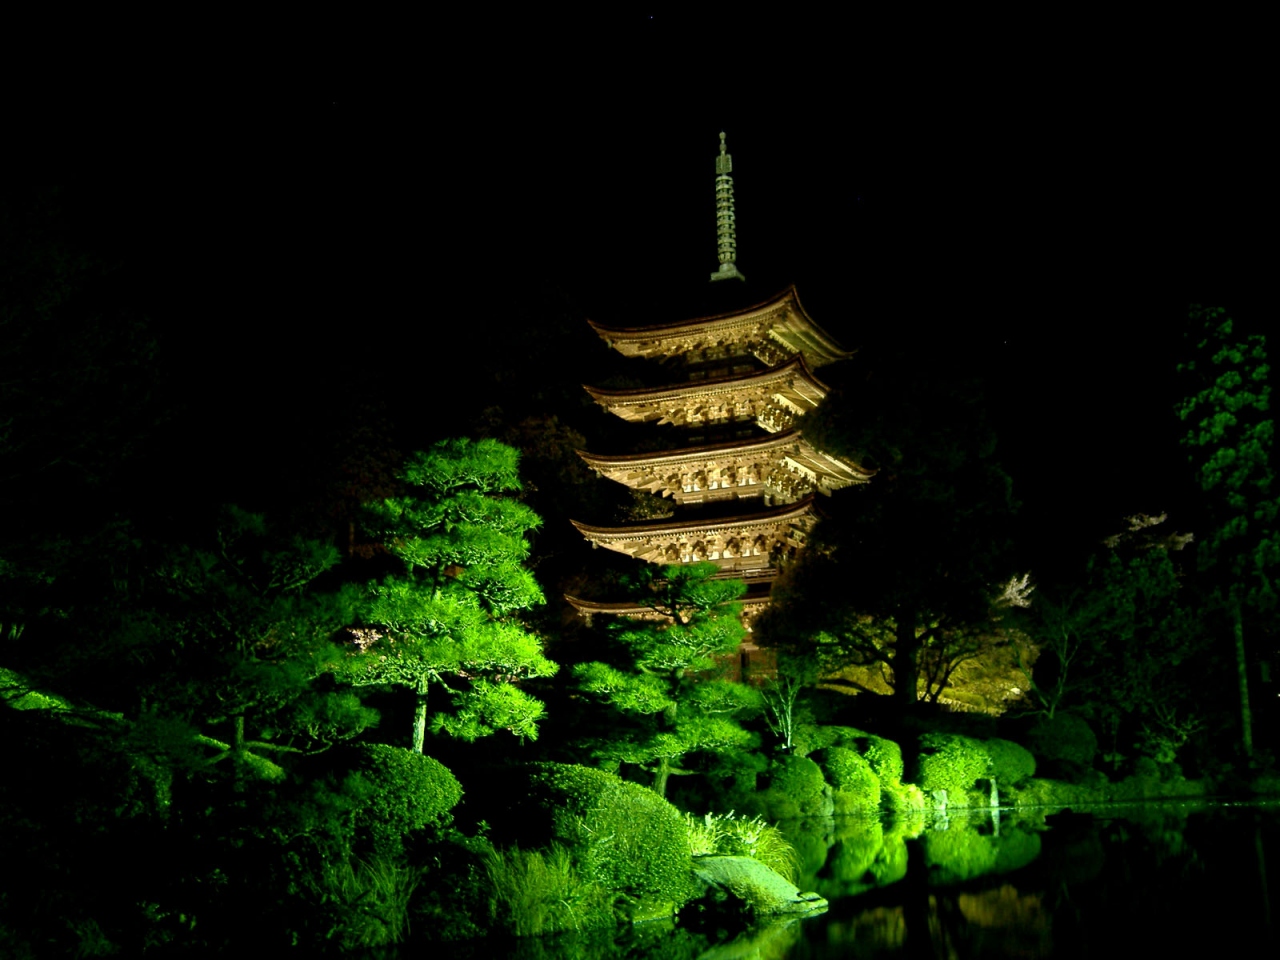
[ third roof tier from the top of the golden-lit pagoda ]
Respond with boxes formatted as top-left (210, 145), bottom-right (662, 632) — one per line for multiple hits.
top-left (577, 430), bottom-right (872, 504)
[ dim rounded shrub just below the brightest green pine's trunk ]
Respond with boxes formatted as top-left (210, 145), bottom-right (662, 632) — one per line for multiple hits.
top-left (352, 744), bottom-right (462, 849)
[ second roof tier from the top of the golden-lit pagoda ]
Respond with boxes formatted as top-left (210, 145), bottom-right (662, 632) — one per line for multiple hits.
top-left (586, 355), bottom-right (829, 433)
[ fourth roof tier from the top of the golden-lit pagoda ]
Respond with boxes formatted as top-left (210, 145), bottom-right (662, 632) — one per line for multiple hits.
top-left (572, 495), bottom-right (818, 582)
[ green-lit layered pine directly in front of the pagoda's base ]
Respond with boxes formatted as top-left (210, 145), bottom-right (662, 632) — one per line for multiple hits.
top-left (573, 563), bottom-right (760, 796)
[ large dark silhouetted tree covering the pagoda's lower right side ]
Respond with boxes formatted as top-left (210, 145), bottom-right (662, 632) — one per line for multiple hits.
top-left (762, 352), bottom-right (1015, 708)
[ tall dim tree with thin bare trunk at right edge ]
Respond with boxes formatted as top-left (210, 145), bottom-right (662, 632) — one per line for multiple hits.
top-left (1178, 305), bottom-right (1280, 756)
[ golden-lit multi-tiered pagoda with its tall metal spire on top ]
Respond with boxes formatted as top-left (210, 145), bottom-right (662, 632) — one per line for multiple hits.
top-left (568, 133), bottom-right (870, 660)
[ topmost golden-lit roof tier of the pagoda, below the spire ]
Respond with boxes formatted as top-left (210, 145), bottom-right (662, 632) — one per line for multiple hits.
top-left (591, 287), bottom-right (854, 370)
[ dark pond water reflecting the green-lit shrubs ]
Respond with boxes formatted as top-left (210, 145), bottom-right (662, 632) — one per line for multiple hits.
top-left (433, 804), bottom-right (1280, 960)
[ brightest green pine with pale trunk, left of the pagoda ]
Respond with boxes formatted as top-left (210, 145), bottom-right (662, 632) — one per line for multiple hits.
top-left (339, 439), bottom-right (557, 753)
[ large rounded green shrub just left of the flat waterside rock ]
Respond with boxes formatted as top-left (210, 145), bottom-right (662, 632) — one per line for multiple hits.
top-left (520, 763), bottom-right (691, 905)
